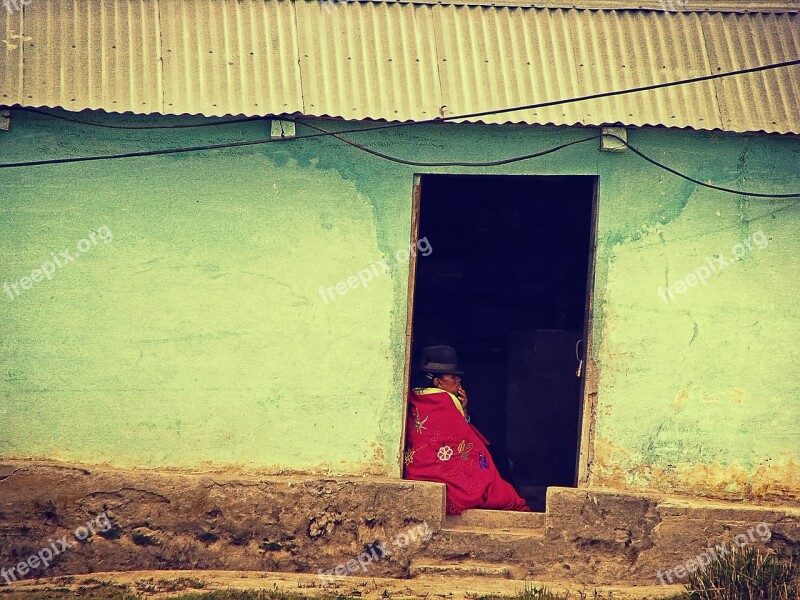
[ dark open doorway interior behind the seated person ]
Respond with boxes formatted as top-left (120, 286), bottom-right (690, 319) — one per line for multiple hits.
top-left (412, 175), bottom-right (596, 511)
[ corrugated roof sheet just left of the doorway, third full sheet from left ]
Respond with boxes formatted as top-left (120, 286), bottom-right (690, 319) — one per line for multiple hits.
top-left (296, 1), bottom-right (442, 121)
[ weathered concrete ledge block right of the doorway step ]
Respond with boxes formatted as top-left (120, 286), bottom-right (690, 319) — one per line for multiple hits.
top-left (543, 488), bottom-right (800, 585)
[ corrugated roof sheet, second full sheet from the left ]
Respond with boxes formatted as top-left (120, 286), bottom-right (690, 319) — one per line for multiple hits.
top-left (162, 0), bottom-right (303, 115)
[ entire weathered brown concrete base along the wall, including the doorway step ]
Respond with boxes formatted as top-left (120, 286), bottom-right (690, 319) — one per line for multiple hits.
top-left (0, 461), bottom-right (800, 585)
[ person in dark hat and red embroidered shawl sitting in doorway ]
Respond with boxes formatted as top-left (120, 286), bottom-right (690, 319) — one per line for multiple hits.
top-left (404, 346), bottom-right (530, 515)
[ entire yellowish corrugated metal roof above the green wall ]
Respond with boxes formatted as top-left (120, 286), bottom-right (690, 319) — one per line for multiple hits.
top-left (0, 0), bottom-right (800, 133)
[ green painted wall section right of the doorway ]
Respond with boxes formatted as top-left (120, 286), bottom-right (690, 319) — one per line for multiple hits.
top-left (590, 131), bottom-right (800, 499)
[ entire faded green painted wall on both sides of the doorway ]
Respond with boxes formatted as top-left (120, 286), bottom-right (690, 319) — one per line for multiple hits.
top-left (0, 113), bottom-right (800, 497)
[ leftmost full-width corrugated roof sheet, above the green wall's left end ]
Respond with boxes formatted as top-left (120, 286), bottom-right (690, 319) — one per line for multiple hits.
top-left (17, 0), bottom-right (164, 113)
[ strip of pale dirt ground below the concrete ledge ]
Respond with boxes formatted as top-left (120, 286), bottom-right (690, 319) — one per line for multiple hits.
top-left (0, 570), bottom-right (682, 600)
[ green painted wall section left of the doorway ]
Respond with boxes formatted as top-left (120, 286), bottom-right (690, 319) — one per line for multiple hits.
top-left (0, 114), bottom-right (411, 475)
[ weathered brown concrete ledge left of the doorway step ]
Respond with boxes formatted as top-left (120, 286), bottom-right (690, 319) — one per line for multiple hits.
top-left (0, 461), bottom-right (445, 585)
